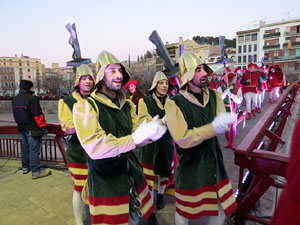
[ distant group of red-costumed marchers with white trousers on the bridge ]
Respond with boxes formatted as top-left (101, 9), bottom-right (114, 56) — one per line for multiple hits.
top-left (210, 62), bottom-right (286, 150)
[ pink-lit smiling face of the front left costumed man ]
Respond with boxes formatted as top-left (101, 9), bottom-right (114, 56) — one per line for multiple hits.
top-left (103, 63), bottom-right (123, 91)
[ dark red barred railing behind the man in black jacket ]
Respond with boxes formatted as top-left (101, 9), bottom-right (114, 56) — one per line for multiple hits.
top-left (0, 124), bottom-right (67, 164)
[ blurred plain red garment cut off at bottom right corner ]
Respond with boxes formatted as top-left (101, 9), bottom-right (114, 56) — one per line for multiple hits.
top-left (271, 119), bottom-right (300, 225)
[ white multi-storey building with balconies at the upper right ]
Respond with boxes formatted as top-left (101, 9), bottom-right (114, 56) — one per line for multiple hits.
top-left (236, 19), bottom-right (300, 80)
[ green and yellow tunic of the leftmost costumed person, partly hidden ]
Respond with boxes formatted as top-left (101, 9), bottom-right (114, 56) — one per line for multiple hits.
top-left (58, 91), bottom-right (88, 192)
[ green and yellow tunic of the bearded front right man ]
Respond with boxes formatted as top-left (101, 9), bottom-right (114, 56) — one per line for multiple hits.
top-left (165, 88), bottom-right (236, 219)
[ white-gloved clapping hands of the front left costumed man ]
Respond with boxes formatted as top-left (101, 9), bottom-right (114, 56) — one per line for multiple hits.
top-left (132, 115), bottom-right (167, 147)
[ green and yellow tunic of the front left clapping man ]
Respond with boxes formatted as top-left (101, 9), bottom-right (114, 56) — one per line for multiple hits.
top-left (73, 92), bottom-right (154, 224)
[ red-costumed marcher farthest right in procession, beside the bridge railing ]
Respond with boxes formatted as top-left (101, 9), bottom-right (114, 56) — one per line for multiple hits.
top-left (268, 65), bottom-right (283, 104)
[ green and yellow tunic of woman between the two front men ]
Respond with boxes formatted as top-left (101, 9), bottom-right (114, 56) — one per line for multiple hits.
top-left (138, 93), bottom-right (174, 190)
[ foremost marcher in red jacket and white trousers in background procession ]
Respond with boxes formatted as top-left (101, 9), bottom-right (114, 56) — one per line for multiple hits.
top-left (241, 63), bottom-right (261, 120)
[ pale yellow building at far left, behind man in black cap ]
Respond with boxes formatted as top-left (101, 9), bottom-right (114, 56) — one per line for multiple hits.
top-left (0, 54), bottom-right (45, 96)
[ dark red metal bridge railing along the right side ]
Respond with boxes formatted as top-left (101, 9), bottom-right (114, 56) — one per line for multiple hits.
top-left (234, 82), bottom-right (300, 225)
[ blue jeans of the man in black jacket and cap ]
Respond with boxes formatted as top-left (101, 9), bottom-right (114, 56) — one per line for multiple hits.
top-left (21, 130), bottom-right (42, 175)
